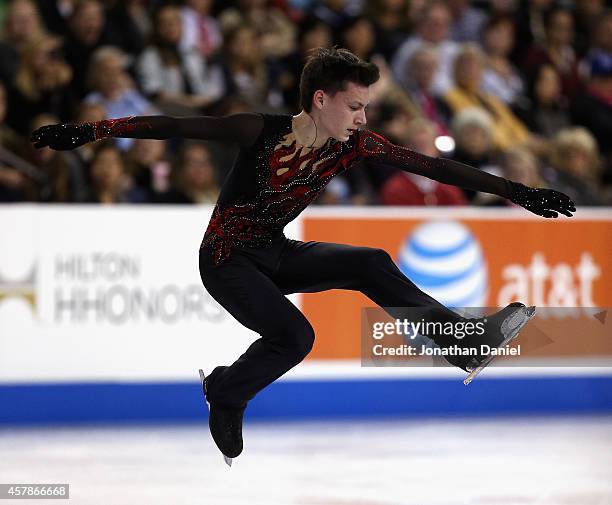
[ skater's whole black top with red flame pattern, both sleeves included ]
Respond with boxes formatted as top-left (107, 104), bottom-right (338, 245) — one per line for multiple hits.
top-left (96, 113), bottom-right (510, 264)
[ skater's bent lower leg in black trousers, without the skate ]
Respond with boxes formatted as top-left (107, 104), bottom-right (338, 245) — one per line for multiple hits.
top-left (201, 254), bottom-right (314, 408)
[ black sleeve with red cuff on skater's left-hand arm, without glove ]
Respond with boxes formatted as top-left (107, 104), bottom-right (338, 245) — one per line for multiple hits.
top-left (93, 113), bottom-right (263, 147)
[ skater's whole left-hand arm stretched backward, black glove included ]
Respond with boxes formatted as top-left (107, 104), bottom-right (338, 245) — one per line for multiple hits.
top-left (30, 113), bottom-right (263, 151)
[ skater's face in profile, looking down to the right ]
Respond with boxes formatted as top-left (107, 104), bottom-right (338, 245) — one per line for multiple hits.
top-left (314, 82), bottom-right (370, 142)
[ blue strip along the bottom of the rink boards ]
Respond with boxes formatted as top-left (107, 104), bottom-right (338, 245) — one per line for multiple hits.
top-left (0, 376), bottom-right (612, 424)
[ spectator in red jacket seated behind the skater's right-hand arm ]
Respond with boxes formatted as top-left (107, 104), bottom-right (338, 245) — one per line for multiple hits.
top-left (380, 118), bottom-right (466, 205)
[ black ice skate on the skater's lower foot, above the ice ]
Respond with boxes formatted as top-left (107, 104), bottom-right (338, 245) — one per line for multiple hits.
top-left (199, 369), bottom-right (244, 466)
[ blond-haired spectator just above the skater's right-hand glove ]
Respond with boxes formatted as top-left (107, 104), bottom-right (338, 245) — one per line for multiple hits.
top-left (542, 127), bottom-right (604, 205)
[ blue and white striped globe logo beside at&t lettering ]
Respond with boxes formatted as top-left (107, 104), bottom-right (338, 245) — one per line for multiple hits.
top-left (398, 221), bottom-right (488, 307)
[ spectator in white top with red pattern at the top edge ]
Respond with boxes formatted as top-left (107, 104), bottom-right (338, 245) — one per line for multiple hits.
top-left (181, 0), bottom-right (223, 59)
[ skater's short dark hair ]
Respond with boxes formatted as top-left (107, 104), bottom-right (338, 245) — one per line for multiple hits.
top-left (300, 47), bottom-right (380, 112)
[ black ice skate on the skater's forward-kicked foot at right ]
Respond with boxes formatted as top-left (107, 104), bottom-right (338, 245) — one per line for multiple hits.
top-left (444, 302), bottom-right (535, 386)
